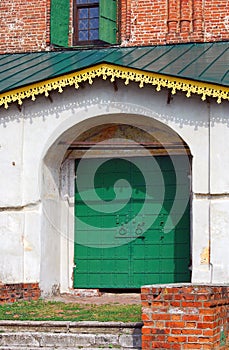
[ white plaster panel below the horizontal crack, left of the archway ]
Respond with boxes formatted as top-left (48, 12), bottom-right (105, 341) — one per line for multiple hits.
top-left (0, 207), bottom-right (41, 283)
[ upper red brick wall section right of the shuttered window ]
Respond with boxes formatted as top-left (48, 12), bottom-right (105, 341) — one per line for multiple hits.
top-left (121, 0), bottom-right (229, 46)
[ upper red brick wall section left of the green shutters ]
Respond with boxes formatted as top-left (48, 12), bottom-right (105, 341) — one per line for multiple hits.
top-left (0, 0), bottom-right (50, 53)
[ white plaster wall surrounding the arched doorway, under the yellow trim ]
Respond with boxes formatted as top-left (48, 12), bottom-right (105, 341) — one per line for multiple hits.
top-left (0, 80), bottom-right (229, 293)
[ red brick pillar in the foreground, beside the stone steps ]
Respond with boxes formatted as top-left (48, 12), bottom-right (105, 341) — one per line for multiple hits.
top-left (141, 284), bottom-right (229, 350)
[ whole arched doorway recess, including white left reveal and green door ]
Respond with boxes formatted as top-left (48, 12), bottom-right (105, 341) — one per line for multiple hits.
top-left (40, 113), bottom-right (191, 293)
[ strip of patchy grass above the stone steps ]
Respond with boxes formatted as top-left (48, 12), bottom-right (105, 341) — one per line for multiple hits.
top-left (0, 300), bottom-right (141, 322)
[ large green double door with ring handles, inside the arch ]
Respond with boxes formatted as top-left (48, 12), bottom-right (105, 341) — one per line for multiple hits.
top-left (74, 156), bottom-right (190, 288)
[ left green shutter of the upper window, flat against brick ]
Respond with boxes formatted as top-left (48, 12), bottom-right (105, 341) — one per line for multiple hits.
top-left (50, 0), bottom-right (70, 46)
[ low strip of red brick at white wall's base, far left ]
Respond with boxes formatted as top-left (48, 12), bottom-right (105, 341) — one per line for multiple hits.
top-left (0, 283), bottom-right (41, 304)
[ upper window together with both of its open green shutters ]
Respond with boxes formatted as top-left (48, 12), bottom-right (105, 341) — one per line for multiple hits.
top-left (51, 0), bottom-right (117, 47)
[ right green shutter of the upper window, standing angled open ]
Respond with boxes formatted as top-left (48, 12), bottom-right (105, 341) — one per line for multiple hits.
top-left (99, 0), bottom-right (117, 44)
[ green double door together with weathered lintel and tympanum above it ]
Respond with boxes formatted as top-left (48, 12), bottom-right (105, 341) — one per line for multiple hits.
top-left (66, 123), bottom-right (191, 288)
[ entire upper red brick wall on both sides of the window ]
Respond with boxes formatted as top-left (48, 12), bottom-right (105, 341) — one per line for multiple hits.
top-left (0, 0), bottom-right (229, 53)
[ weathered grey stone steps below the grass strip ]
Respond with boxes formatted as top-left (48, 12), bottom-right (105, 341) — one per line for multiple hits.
top-left (0, 321), bottom-right (142, 350)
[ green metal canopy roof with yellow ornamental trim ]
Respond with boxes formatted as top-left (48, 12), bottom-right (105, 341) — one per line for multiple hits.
top-left (0, 42), bottom-right (229, 105)
